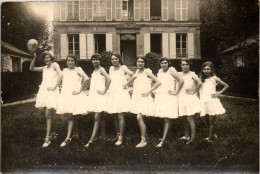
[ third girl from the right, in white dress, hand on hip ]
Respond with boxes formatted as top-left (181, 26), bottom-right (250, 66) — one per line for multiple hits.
top-left (154, 57), bottom-right (184, 147)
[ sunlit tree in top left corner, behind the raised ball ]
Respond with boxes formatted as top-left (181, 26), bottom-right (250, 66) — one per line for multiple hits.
top-left (1, 2), bottom-right (52, 51)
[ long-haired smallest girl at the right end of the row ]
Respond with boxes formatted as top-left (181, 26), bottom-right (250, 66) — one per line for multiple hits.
top-left (200, 62), bottom-right (229, 142)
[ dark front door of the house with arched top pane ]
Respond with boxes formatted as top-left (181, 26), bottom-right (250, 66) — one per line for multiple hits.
top-left (120, 34), bottom-right (136, 66)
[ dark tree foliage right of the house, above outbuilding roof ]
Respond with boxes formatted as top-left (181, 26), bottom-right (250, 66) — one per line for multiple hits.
top-left (200, 0), bottom-right (259, 58)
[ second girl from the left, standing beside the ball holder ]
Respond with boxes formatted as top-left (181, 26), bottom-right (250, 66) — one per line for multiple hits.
top-left (57, 55), bottom-right (88, 147)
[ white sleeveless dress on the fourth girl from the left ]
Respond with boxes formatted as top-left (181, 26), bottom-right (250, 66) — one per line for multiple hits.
top-left (106, 65), bottom-right (130, 114)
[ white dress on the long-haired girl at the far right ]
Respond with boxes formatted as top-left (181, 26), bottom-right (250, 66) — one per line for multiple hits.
top-left (200, 76), bottom-right (226, 116)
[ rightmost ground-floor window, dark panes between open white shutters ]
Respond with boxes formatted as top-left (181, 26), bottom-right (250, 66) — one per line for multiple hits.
top-left (176, 34), bottom-right (188, 58)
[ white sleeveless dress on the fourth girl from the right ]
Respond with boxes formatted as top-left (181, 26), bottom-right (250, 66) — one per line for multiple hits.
top-left (131, 69), bottom-right (154, 116)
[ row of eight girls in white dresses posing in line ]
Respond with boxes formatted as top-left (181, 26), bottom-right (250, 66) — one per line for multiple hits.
top-left (30, 52), bottom-right (228, 148)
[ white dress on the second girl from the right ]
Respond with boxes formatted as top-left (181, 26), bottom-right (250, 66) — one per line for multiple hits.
top-left (178, 71), bottom-right (200, 116)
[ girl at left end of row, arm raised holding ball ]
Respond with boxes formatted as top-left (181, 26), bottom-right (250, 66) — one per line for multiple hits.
top-left (30, 52), bottom-right (61, 147)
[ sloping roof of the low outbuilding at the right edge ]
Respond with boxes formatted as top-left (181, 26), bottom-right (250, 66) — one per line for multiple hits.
top-left (220, 37), bottom-right (259, 55)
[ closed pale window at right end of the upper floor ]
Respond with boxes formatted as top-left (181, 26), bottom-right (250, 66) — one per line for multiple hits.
top-left (175, 0), bottom-right (188, 21)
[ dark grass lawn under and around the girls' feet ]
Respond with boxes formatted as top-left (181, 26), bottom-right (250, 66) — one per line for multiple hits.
top-left (1, 98), bottom-right (259, 173)
